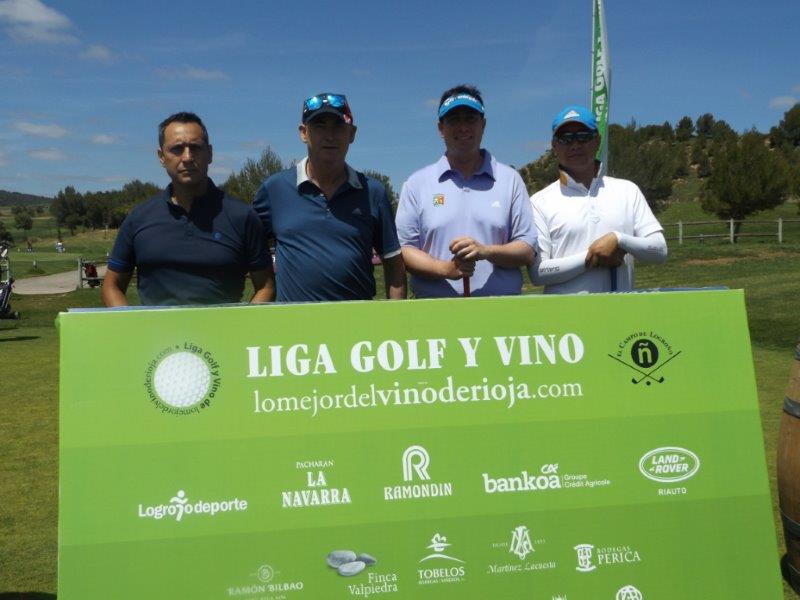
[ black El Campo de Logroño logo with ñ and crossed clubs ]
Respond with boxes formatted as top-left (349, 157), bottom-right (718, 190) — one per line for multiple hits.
top-left (608, 331), bottom-right (682, 386)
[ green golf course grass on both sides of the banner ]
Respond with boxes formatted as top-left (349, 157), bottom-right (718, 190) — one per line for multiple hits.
top-left (0, 241), bottom-right (800, 599)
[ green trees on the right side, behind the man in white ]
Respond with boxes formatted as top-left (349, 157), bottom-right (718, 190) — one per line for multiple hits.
top-left (520, 103), bottom-right (800, 232)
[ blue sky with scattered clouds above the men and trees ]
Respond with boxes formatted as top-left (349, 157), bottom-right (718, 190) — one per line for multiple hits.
top-left (0, 0), bottom-right (800, 195)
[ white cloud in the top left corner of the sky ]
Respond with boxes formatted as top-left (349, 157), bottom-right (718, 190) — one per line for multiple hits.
top-left (0, 0), bottom-right (78, 44)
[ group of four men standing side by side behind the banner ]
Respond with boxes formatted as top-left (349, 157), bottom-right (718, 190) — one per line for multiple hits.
top-left (102, 97), bottom-right (666, 306)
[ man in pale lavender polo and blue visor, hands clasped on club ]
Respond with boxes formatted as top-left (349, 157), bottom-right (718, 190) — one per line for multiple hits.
top-left (397, 85), bottom-right (536, 298)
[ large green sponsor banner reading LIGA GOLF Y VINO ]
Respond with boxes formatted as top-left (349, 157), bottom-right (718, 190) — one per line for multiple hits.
top-left (58, 291), bottom-right (782, 600)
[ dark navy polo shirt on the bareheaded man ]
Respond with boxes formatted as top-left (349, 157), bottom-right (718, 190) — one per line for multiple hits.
top-left (108, 179), bottom-right (269, 306)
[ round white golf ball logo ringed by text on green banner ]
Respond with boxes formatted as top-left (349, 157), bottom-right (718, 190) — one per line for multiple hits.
top-left (144, 342), bottom-right (221, 415)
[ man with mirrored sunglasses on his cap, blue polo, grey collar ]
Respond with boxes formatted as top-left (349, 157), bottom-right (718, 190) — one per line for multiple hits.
top-left (253, 94), bottom-right (406, 302)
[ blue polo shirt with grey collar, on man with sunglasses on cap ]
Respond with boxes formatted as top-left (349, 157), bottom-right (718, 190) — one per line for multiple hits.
top-left (253, 157), bottom-right (400, 302)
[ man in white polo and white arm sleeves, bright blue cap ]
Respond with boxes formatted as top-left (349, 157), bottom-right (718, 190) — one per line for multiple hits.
top-left (529, 105), bottom-right (667, 294)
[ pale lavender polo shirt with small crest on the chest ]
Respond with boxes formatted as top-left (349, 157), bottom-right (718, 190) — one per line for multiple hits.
top-left (397, 150), bottom-right (536, 298)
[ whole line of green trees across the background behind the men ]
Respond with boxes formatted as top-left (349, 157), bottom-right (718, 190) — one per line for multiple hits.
top-left (36, 103), bottom-right (800, 241)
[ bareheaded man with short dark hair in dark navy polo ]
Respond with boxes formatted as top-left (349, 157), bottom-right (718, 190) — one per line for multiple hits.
top-left (102, 112), bottom-right (274, 306)
